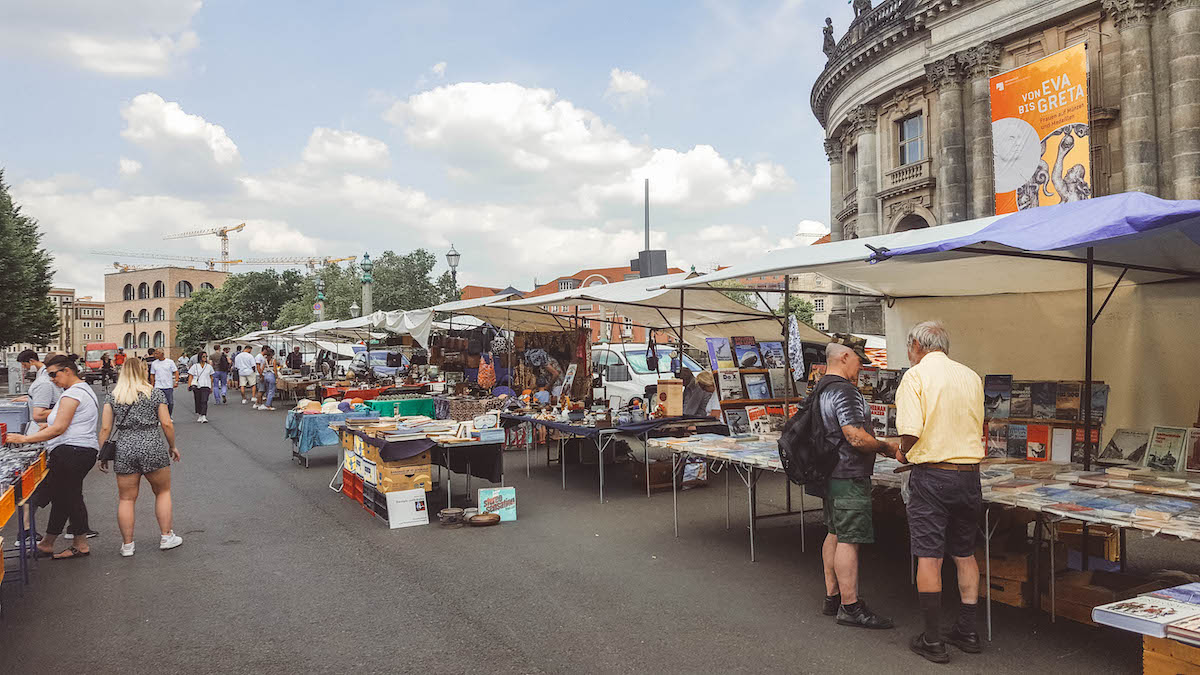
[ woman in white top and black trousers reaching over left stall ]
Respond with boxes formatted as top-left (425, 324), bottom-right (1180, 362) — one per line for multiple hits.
top-left (8, 354), bottom-right (100, 560)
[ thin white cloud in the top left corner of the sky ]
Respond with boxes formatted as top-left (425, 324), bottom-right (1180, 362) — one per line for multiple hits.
top-left (0, 0), bottom-right (203, 77)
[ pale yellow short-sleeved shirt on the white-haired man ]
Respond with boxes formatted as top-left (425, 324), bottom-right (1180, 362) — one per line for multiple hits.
top-left (896, 352), bottom-right (984, 464)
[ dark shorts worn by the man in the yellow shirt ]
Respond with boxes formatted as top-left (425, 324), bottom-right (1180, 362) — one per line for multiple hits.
top-left (908, 466), bottom-right (983, 558)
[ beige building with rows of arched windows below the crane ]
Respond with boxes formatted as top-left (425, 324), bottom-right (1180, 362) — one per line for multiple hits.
top-left (104, 267), bottom-right (229, 358)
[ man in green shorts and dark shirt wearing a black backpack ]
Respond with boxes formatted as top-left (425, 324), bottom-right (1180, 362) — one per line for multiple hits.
top-left (810, 342), bottom-right (900, 628)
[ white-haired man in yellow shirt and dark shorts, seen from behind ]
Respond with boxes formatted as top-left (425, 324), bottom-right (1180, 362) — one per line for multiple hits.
top-left (896, 321), bottom-right (984, 663)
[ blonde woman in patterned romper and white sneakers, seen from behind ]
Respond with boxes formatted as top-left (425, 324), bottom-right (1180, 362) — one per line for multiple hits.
top-left (100, 357), bottom-right (184, 557)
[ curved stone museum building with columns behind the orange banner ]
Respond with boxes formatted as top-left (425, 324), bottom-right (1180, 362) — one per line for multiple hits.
top-left (811, 0), bottom-right (1200, 334)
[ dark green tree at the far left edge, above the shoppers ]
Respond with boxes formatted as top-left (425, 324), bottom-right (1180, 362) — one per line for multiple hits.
top-left (0, 171), bottom-right (59, 345)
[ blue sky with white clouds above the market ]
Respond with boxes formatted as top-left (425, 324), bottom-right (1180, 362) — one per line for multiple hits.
top-left (0, 0), bottom-right (852, 298)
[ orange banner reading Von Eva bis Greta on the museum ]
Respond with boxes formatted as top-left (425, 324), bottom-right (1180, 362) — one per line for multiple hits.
top-left (990, 43), bottom-right (1092, 215)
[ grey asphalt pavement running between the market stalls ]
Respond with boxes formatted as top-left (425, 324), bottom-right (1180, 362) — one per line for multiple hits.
top-left (0, 389), bottom-right (1180, 674)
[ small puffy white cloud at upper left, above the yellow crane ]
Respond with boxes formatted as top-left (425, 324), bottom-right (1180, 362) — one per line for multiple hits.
top-left (121, 92), bottom-right (241, 166)
